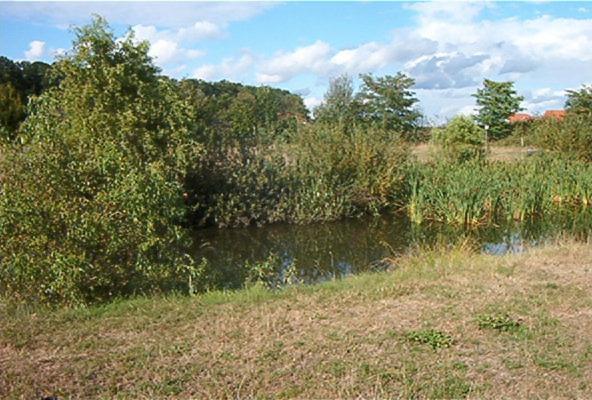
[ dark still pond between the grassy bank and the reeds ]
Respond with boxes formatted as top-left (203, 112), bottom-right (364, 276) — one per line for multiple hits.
top-left (193, 213), bottom-right (592, 289)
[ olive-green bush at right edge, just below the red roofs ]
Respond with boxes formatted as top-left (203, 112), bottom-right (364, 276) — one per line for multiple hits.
top-left (531, 113), bottom-right (592, 161)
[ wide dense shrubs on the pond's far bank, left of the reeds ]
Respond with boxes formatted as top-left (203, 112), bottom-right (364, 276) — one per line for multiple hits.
top-left (191, 125), bottom-right (408, 226)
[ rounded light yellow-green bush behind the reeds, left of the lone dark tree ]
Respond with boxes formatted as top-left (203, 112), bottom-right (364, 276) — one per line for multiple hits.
top-left (433, 116), bottom-right (485, 162)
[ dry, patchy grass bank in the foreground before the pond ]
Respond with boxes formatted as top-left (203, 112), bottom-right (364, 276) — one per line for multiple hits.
top-left (0, 244), bottom-right (592, 398)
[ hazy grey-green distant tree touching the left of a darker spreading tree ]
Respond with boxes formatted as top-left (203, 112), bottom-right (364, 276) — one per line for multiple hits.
top-left (314, 75), bottom-right (354, 126)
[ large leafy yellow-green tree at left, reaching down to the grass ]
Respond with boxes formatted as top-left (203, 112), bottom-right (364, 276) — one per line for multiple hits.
top-left (0, 14), bottom-right (196, 304)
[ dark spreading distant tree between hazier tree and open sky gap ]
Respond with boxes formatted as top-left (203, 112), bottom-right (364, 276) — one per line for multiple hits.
top-left (356, 72), bottom-right (421, 136)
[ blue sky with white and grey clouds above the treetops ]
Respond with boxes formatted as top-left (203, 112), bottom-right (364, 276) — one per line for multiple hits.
top-left (0, 1), bottom-right (592, 123)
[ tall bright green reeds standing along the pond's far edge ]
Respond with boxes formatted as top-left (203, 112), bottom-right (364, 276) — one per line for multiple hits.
top-left (407, 157), bottom-right (592, 226)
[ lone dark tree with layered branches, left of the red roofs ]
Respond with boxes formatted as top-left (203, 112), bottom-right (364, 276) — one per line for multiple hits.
top-left (473, 79), bottom-right (524, 140)
